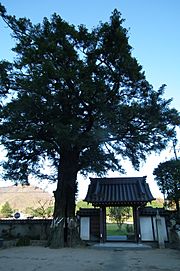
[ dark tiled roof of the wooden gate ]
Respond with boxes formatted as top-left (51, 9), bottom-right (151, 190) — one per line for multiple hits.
top-left (85, 177), bottom-right (154, 206)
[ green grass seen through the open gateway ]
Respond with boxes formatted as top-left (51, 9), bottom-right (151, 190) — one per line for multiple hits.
top-left (106, 223), bottom-right (134, 236)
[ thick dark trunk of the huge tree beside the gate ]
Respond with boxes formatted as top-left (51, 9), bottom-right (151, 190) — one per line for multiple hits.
top-left (50, 148), bottom-right (79, 248)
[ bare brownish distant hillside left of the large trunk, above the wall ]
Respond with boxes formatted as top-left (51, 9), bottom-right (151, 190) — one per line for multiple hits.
top-left (0, 185), bottom-right (53, 212)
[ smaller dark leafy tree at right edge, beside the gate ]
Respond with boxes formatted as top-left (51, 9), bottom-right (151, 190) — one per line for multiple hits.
top-left (153, 159), bottom-right (180, 212)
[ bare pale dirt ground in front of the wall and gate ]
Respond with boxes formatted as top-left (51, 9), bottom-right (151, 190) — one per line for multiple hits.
top-left (0, 246), bottom-right (180, 271)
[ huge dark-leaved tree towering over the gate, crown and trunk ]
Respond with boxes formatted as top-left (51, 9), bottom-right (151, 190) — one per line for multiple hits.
top-left (0, 6), bottom-right (179, 247)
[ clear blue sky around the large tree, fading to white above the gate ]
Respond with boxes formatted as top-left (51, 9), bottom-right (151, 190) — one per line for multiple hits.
top-left (0, 0), bottom-right (180, 198)
